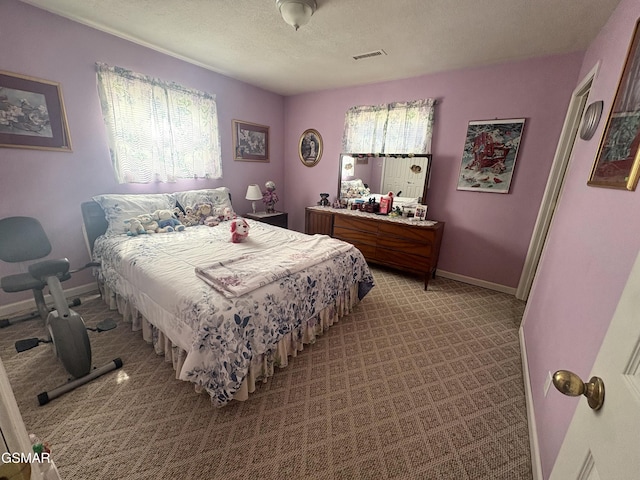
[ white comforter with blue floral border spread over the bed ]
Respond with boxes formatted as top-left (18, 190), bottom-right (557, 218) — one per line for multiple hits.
top-left (94, 219), bottom-right (373, 406)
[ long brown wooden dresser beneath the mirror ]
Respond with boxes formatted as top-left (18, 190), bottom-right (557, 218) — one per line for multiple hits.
top-left (305, 207), bottom-right (444, 290)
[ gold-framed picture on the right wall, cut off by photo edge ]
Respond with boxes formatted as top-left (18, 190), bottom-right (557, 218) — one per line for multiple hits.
top-left (587, 21), bottom-right (640, 191)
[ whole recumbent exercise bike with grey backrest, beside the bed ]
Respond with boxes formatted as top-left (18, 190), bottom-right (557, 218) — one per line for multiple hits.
top-left (0, 217), bottom-right (122, 405)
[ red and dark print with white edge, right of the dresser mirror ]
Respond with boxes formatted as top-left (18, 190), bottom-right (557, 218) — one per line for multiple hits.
top-left (458, 118), bottom-right (524, 193)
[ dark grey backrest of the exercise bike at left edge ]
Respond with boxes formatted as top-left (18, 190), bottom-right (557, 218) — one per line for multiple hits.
top-left (0, 217), bottom-right (51, 263)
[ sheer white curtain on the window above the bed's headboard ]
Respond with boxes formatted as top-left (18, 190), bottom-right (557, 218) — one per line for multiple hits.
top-left (96, 63), bottom-right (222, 183)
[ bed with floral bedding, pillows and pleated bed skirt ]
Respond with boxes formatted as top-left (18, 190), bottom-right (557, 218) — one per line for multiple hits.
top-left (82, 187), bottom-right (374, 406)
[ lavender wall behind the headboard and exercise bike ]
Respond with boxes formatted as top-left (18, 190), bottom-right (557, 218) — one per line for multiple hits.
top-left (0, 0), bottom-right (286, 304)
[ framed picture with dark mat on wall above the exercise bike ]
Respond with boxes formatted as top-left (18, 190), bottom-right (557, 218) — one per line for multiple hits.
top-left (0, 71), bottom-right (71, 151)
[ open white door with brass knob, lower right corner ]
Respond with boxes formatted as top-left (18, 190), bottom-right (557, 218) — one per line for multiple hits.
top-left (550, 249), bottom-right (640, 480)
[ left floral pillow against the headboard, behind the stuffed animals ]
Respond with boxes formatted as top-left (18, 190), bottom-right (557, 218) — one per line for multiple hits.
top-left (93, 193), bottom-right (176, 236)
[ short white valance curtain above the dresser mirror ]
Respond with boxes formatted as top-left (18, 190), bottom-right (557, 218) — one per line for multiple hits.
top-left (342, 98), bottom-right (435, 154)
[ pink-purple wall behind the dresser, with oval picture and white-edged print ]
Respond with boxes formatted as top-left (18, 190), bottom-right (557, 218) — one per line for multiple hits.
top-left (284, 54), bottom-right (582, 288)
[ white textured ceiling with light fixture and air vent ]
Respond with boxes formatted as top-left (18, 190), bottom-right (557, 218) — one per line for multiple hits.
top-left (23, 0), bottom-right (620, 95)
